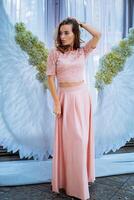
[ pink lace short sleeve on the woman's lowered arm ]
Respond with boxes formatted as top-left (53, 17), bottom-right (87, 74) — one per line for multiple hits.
top-left (46, 48), bottom-right (57, 75)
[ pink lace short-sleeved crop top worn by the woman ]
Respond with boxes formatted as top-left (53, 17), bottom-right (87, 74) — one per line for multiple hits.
top-left (46, 42), bottom-right (93, 82)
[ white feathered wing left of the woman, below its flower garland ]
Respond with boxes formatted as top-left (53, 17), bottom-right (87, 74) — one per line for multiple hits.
top-left (0, 1), bottom-right (54, 160)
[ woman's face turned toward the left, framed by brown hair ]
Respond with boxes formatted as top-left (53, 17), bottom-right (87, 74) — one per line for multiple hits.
top-left (60, 24), bottom-right (74, 47)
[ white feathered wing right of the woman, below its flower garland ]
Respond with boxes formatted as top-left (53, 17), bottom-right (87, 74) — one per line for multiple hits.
top-left (94, 55), bottom-right (134, 157)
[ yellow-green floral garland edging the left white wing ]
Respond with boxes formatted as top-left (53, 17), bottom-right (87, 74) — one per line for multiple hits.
top-left (15, 22), bottom-right (48, 89)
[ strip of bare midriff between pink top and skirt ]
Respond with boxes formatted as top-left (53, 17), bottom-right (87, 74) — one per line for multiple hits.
top-left (58, 80), bottom-right (84, 87)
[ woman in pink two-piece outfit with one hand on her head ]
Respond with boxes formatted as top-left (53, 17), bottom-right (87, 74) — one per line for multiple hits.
top-left (46, 18), bottom-right (101, 200)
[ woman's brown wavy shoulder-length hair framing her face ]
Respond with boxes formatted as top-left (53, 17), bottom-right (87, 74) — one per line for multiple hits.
top-left (55, 17), bottom-right (81, 53)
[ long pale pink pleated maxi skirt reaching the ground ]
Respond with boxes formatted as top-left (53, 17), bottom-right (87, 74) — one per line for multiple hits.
top-left (52, 82), bottom-right (95, 200)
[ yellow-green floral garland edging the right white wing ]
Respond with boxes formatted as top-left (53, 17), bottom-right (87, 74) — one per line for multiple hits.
top-left (95, 28), bottom-right (134, 90)
